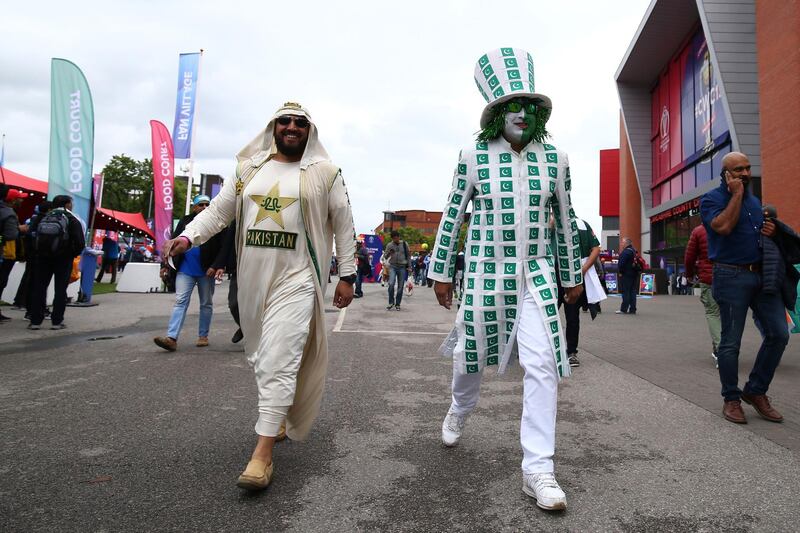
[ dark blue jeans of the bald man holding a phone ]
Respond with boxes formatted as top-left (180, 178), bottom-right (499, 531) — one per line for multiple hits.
top-left (711, 265), bottom-right (789, 401)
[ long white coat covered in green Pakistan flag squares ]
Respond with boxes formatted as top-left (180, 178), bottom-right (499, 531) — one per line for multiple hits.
top-left (428, 137), bottom-right (583, 376)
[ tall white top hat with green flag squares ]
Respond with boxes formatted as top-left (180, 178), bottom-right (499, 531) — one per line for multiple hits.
top-left (475, 48), bottom-right (553, 128)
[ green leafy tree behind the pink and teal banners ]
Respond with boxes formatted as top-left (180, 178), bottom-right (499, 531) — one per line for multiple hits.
top-left (102, 154), bottom-right (153, 216)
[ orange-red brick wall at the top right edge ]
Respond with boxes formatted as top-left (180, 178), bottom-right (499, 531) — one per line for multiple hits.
top-left (756, 0), bottom-right (800, 230)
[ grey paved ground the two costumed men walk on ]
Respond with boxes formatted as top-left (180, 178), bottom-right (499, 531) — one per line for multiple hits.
top-left (0, 280), bottom-right (800, 532)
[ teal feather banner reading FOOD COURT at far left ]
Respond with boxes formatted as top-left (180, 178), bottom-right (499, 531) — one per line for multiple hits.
top-left (47, 58), bottom-right (94, 224)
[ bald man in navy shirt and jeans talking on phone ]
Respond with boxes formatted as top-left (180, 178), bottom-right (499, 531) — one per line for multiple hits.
top-left (700, 152), bottom-right (789, 424)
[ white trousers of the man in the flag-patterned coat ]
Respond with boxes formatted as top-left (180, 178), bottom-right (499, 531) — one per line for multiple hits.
top-left (450, 288), bottom-right (558, 473)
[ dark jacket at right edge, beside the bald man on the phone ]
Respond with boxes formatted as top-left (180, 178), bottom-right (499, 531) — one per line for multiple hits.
top-left (761, 219), bottom-right (800, 311)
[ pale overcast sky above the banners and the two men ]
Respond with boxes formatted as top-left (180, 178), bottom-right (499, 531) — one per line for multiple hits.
top-left (0, 0), bottom-right (649, 234)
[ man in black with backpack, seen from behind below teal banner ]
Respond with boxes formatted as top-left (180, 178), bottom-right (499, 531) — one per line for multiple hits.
top-left (28, 195), bottom-right (86, 329)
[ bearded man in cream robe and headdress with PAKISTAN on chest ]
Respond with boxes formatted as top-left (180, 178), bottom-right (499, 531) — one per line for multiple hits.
top-left (165, 102), bottom-right (355, 490)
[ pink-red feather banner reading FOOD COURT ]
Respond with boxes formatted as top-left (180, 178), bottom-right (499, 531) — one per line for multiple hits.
top-left (150, 120), bottom-right (175, 251)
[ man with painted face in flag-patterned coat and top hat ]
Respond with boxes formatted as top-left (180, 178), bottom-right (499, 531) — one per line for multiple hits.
top-left (428, 48), bottom-right (583, 510)
